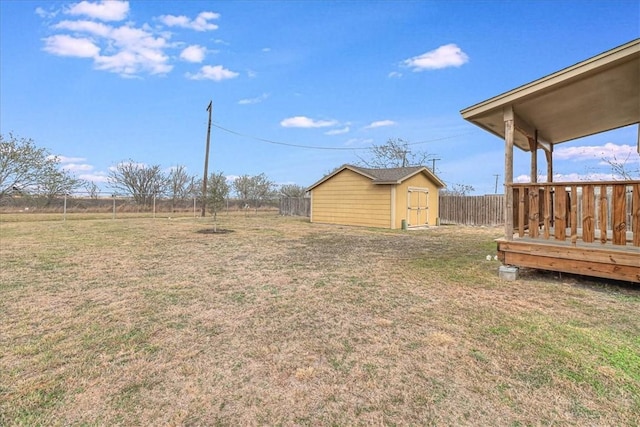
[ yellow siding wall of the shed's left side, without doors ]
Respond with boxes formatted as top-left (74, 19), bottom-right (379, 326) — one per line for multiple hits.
top-left (311, 169), bottom-right (392, 228)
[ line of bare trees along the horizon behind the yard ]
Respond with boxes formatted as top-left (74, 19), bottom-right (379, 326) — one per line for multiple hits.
top-left (0, 133), bottom-right (524, 208)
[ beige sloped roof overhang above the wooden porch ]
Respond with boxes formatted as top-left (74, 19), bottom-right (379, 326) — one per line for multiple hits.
top-left (460, 39), bottom-right (640, 151)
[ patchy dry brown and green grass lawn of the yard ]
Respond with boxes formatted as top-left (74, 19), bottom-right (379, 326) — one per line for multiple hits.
top-left (0, 213), bottom-right (640, 426)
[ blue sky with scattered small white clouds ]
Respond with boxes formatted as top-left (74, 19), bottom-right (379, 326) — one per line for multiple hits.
top-left (0, 0), bottom-right (640, 194)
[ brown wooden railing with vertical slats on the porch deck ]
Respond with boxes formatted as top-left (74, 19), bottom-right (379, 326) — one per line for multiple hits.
top-left (507, 181), bottom-right (640, 246)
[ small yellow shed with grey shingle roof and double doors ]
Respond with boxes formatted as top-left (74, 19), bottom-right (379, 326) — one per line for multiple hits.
top-left (307, 165), bottom-right (445, 229)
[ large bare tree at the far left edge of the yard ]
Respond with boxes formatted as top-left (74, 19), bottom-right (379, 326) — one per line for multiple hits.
top-left (0, 133), bottom-right (70, 200)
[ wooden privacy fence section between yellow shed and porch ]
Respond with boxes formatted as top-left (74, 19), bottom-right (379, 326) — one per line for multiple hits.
top-left (438, 194), bottom-right (504, 226)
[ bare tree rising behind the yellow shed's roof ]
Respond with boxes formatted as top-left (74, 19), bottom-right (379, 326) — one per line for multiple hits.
top-left (360, 138), bottom-right (431, 168)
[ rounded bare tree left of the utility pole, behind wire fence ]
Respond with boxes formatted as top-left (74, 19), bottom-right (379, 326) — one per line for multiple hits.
top-left (109, 160), bottom-right (167, 206)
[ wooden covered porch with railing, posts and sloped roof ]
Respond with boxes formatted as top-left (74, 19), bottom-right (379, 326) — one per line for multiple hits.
top-left (461, 39), bottom-right (640, 283)
